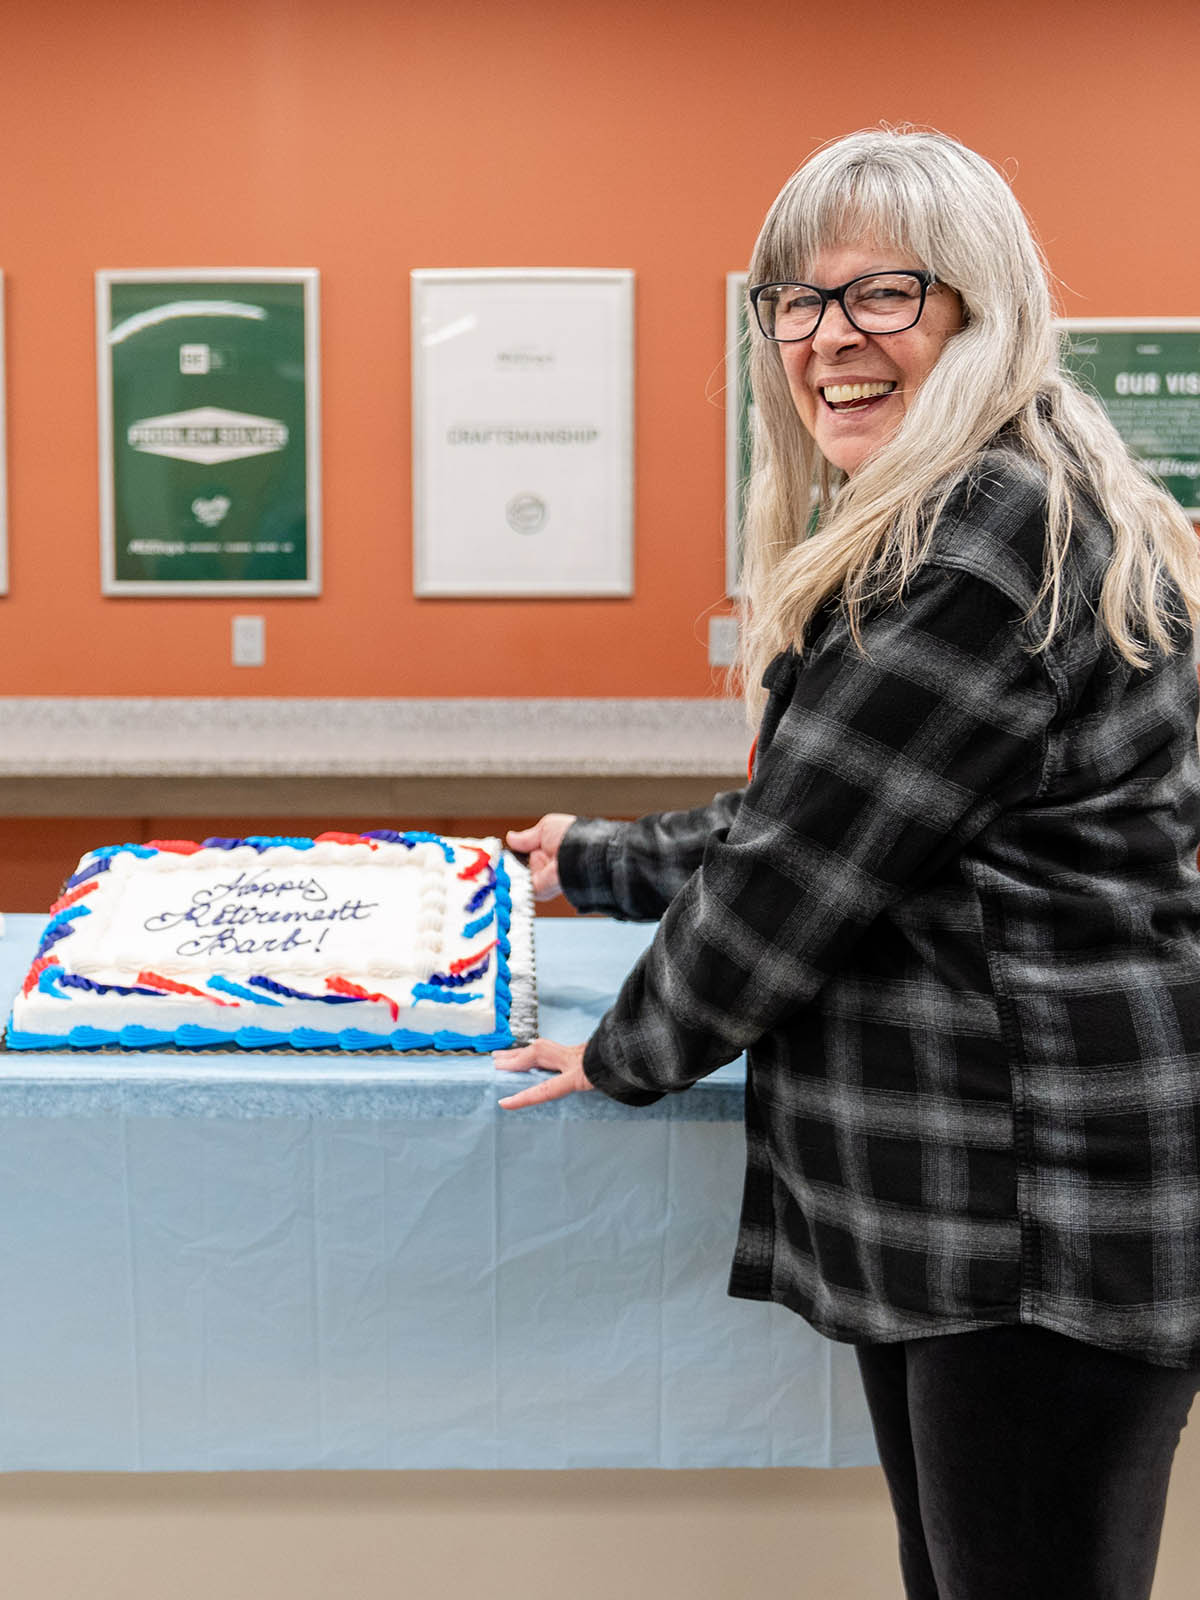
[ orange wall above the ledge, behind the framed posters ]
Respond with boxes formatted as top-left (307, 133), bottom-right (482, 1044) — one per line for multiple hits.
top-left (0, 0), bottom-right (1200, 696)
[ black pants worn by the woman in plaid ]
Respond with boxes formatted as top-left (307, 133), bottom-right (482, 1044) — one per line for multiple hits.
top-left (856, 1326), bottom-right (1200, 1600)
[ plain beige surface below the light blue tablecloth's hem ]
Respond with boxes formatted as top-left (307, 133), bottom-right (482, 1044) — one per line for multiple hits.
top-left (0, 1413), bottom-right (1200, 1600)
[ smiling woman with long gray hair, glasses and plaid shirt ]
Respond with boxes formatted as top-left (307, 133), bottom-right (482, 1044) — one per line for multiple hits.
top-left (499, 124), bottom-right (1200, 1600)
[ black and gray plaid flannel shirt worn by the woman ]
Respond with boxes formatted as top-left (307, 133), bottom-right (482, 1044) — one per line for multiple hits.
top-left (558, 450), bottom-right (1200, 1366)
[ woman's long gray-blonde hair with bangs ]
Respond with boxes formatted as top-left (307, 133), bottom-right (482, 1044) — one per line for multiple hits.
top-left (739, 130), bottom-right (1200, 717)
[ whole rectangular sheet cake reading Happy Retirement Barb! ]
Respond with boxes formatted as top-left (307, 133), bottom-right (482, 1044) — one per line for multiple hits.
top-left (8, 829), bottom-right (536, 1051)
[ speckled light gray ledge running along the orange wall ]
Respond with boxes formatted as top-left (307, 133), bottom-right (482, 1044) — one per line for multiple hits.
top-left (0, 696), bottom-right (750, 780)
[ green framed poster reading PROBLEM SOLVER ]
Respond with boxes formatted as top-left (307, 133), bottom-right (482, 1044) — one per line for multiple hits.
top-left (96, 267), bottom-right (320, 595)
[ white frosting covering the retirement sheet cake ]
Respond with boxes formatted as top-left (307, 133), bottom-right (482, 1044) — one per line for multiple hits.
top-left (13, 838), bottom-right (533, 1035)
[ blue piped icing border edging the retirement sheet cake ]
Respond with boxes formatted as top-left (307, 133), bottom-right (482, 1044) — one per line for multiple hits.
top-left (5, 829), bottom-right (515, 1054)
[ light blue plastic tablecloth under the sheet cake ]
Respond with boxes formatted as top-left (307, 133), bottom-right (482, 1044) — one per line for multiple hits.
top-left (0, 917), bottom-right (875, 1470)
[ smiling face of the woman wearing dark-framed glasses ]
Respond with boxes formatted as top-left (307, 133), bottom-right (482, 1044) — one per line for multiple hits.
top-left (779, 243), bottom-right (963, 474)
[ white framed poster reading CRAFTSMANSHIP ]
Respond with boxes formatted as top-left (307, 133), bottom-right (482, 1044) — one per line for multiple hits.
top-left (411, 269), bottom-right (634, 597)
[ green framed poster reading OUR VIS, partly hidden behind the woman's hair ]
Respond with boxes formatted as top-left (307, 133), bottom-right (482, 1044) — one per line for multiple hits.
top-left (1059, 317), bottom-right (1200, 522)
